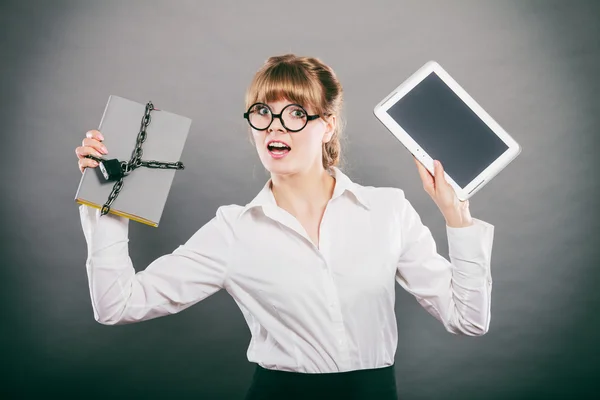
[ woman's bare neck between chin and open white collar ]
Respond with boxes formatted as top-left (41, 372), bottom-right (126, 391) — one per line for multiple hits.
top-left (271, 165), bottom-right (335, 215)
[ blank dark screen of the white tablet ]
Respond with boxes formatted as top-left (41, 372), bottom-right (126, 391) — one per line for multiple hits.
top-left (387, 72), bottom-right (508, 188)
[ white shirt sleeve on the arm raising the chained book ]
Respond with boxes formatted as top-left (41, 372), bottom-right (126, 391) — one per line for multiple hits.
top-left (79, 205), bottom-right (232, 325)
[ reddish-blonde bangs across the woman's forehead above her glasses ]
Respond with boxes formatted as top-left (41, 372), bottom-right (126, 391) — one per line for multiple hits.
top-left (246, 63), bottom-right (323, 115)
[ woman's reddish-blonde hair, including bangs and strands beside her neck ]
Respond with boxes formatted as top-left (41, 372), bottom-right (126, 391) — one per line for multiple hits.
top-left (246, 54), bottom-right (344, 169)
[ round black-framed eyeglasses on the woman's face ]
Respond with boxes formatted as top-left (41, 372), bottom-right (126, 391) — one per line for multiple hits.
top-left (244, 103), bottom-right (319, 132)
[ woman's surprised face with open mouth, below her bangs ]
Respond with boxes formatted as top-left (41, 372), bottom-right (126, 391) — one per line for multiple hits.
top-left (251, 99), bottom-right (335, 175)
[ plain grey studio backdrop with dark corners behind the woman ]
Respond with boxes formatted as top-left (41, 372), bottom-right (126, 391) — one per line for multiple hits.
top-left (0, 0), bottom-right (600, 399)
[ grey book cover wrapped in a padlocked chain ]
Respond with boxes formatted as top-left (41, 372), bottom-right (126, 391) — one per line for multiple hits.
top-left (75, 95), bottom-right (192, 227)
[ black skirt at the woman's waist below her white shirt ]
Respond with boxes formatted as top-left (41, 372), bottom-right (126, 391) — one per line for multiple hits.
top-left (245, 364), bottom-right (398, 400)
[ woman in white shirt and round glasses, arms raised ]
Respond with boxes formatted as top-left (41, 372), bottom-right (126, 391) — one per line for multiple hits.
top-left (76, 54), bottom-right (494, 400)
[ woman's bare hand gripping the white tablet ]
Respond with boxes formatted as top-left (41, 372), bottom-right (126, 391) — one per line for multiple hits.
top-left (413, 156), bottom-right (473, 227)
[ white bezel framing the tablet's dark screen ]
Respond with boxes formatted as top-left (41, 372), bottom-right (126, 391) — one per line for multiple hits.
top-left (373, 61), bottom-right (521, 201)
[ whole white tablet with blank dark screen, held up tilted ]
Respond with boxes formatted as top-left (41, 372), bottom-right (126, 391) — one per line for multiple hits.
top-left (374, 61), bottom-right (521, 200)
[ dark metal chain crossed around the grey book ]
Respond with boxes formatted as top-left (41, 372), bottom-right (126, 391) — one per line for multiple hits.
top-left (101, 101), bottom-right (185, 215)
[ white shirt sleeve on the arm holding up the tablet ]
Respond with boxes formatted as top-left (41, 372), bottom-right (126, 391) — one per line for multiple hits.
top-left (396, 192), bottom-right (494, 336)
